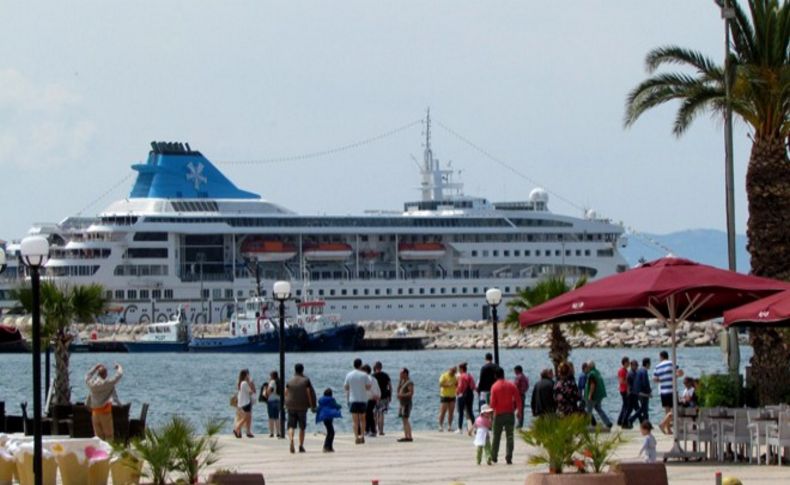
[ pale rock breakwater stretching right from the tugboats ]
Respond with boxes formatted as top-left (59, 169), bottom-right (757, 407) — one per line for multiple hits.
top-left (360, 319), bottom-right (748, 349)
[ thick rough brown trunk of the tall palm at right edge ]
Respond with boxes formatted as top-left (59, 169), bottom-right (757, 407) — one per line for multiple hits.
top-left (746, 136), bottom-right (790, 405)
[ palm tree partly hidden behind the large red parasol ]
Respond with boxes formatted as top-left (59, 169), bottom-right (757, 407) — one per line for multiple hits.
top-left (505, 276), bottom-right (596, 373)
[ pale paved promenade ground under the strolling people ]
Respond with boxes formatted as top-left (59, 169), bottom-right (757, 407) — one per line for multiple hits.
top-left (212, 430), bottom-right (790, 485)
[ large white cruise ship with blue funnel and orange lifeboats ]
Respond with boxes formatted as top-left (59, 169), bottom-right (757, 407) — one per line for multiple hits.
top-left (0, 117), bottom-right (627, 323)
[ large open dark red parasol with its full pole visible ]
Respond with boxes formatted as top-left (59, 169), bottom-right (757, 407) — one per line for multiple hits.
top-left (519, 256), bottom-right (790, 459)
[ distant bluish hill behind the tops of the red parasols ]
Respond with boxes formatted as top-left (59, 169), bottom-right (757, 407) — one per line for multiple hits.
top-left (620, 229), bottom-right (750, 273)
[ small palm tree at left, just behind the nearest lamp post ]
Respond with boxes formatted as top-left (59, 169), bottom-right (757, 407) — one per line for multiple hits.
top-left (15, 281), bottom-right (107, 404)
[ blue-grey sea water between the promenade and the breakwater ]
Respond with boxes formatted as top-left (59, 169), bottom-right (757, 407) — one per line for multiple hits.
top-left (0, 347), bottom-right (752, 434)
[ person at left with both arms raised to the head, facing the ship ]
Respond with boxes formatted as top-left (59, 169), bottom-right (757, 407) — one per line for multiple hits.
top-left (85, 362), bottom-right (123, 441)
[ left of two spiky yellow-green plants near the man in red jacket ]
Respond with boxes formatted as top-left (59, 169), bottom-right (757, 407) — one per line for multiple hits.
top-left (520, 414), bottom-right (589, 473)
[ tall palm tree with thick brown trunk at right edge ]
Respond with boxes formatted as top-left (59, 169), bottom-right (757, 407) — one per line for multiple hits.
top-left (625, 0), bottom-right (790, 404)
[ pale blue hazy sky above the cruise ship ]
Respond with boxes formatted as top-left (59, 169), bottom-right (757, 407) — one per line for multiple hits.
top-left (0, 0), bottom-right (750, 240)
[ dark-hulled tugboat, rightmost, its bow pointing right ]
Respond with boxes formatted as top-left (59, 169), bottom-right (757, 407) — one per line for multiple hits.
top-left (295, 300), bottom-right (365, 352)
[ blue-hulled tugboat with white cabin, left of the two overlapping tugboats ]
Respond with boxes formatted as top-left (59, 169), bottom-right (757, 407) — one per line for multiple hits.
top-left (188, 297), bottom-right (307, 352)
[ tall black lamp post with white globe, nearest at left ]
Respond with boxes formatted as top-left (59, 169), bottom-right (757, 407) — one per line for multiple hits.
top-left (20, 236), bottom-right (49, 485)
